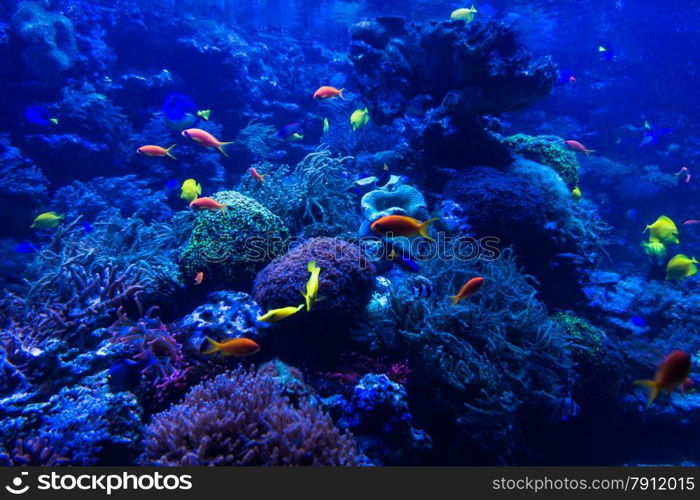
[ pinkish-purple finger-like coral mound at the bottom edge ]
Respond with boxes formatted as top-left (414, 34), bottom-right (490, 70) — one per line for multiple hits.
top-left (142, 367), bottom-right (364, 466)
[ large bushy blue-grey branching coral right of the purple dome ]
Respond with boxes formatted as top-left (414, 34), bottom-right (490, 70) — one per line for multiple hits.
top-left (357, 250), bottom-right (573, 461)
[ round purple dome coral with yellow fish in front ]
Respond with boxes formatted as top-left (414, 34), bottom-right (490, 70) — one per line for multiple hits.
top-left (253, 238), bottom-right (376, 318)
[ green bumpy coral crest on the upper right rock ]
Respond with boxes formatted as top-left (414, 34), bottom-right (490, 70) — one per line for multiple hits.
top-left (503, 134), bottom-right (580, 189)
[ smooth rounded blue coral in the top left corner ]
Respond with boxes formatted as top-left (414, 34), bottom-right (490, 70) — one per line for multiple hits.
top-left (12, 2), bottom-right (78, 79)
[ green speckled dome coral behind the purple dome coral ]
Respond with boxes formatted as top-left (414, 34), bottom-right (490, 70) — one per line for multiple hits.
top-left (180, 191), bottom-right (289, 289)
